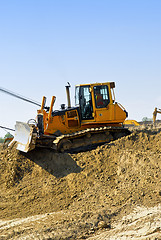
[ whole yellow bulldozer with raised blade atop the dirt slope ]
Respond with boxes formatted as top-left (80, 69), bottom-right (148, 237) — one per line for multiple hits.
top-left (1, 82), bottom-right (131, 152)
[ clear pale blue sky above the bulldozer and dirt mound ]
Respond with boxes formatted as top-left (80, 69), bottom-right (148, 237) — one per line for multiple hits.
top-left (0, 0), bottom-right (161, 136)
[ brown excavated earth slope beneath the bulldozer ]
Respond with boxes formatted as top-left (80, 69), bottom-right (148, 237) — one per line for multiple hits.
top-left (0, 124), bottom-right (161, 240)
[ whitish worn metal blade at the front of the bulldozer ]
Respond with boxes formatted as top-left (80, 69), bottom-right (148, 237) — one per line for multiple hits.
top-left (13, 122), bottom-right (37, 152)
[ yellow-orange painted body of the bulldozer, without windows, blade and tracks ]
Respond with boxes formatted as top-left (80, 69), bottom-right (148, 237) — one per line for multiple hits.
top-left (38, 82), bottom-right (126, 134)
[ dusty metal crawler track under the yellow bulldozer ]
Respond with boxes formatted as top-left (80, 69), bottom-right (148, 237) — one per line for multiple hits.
top-left (53, 127), bottom-right (131, 152)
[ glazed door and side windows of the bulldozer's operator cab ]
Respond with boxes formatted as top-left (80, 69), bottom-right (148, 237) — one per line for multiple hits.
top-left (75, 84), bottom-right (110, 120)
